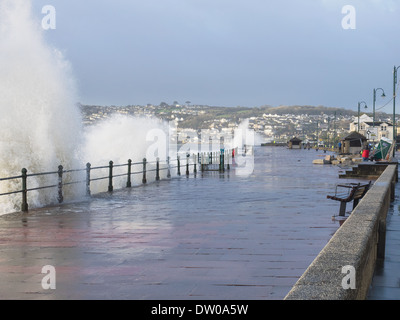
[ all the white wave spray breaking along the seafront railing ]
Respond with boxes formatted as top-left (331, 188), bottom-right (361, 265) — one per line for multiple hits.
top-left (0, 0), bottom-right (256, 214)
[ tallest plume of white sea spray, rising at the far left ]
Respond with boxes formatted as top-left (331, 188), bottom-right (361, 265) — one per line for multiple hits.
top-left (0, 0), bottom-right (82, 214)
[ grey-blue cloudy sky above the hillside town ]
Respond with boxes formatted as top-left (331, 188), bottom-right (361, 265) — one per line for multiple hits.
top-left (32, 0), bottom-right (400, 113)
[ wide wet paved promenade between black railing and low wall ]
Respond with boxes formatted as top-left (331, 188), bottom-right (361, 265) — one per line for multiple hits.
top-left (0, 147), bottom-right (366, 300)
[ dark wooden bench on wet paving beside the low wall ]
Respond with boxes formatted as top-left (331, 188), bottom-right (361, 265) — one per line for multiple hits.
top-left (327, 181), bottom-right (371, 217)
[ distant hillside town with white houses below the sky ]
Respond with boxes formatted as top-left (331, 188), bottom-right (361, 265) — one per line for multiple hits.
top-left (81, 101), bottom-right (399, 147)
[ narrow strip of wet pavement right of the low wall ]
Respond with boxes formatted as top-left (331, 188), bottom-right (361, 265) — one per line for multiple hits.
top-left (368, 183), bottom-right (400, 300)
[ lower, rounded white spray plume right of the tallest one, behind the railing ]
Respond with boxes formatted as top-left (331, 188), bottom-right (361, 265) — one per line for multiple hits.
top-left (82, 114), bottom-right (169, 193)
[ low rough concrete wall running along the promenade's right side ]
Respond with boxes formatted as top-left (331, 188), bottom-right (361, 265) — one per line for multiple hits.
top-left (285, 165), bottom-right (397, 300)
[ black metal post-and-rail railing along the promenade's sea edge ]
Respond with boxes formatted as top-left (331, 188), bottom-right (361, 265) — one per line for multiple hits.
top-left (0, 148), bottom-right (237, 212)
